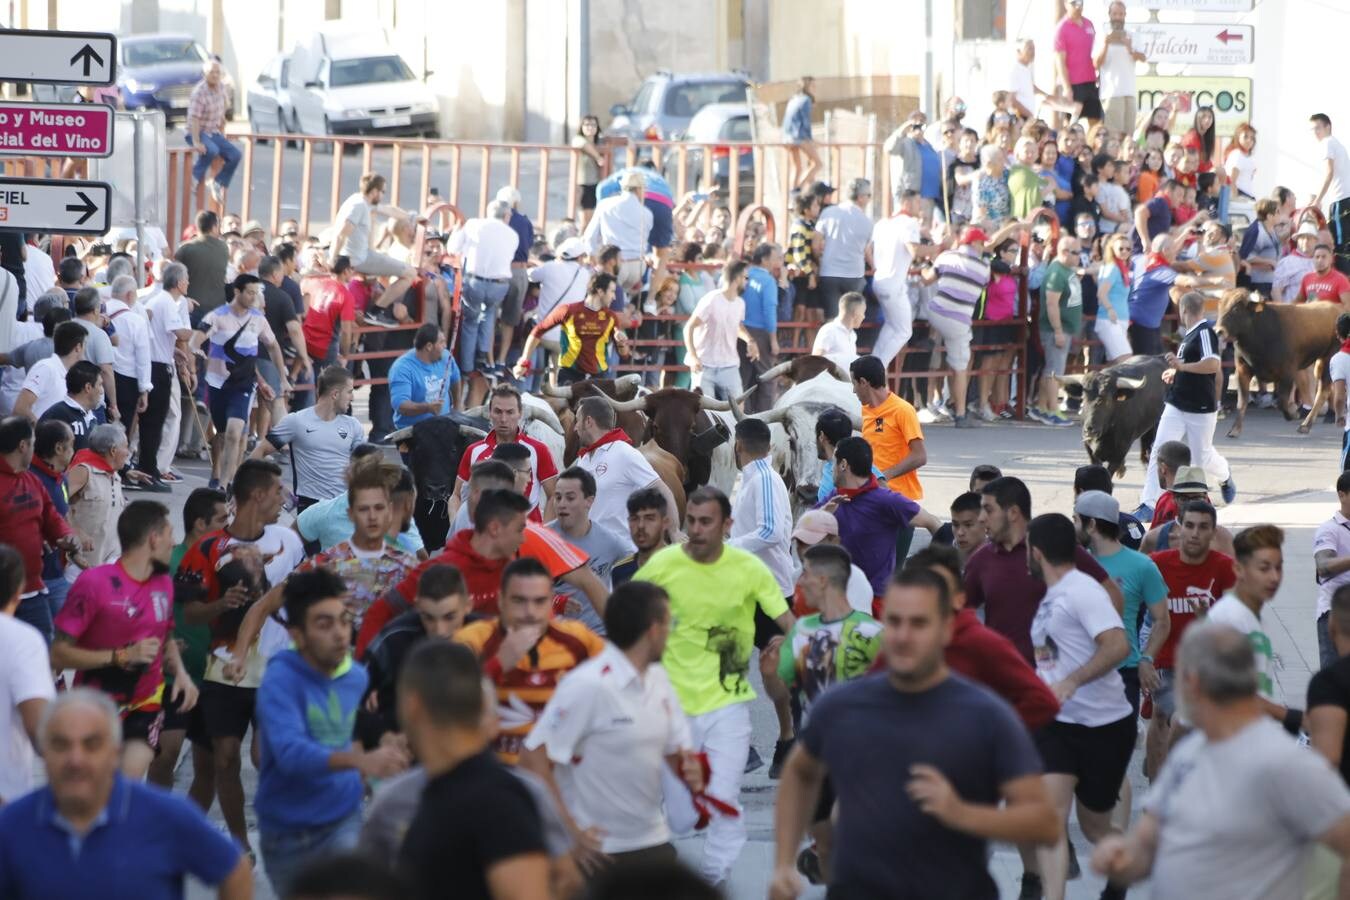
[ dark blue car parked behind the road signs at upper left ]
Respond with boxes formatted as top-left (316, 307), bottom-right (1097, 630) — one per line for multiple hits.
top-left (117, 34), bottom-right (235, 121)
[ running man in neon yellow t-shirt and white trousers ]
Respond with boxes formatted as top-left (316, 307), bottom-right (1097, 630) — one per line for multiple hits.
top-left (633, 487), bottom-right (795, 884)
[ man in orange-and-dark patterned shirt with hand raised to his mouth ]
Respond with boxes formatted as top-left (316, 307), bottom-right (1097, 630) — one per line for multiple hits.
top-left (455, 557), bottom-right (605, 765)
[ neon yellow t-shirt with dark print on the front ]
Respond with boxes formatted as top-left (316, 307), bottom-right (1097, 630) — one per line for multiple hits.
top-left (633, 546), bottom-right (787, 715)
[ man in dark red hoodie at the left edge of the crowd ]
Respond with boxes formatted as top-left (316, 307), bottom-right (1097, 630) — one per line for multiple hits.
top-left (0, 416), bottom-right (80, 644)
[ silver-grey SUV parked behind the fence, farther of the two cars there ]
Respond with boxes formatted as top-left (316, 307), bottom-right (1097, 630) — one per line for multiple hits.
top-left (606, 72), bottom-right (749, 140)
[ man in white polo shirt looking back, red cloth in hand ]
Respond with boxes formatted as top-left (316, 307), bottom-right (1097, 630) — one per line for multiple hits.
top-left (520, 582), bottom-right (703, 862)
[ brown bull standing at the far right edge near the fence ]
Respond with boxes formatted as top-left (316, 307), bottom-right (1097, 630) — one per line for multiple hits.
top-left (1218, 290), bottom-right (1345, 437)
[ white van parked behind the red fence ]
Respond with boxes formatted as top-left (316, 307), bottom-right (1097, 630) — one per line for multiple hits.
top-left (286, 24), bottom-right (440, 138)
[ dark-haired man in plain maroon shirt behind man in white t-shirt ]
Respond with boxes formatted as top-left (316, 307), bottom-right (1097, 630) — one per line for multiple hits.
top-left (965, 476), bottom-right (1125, 665)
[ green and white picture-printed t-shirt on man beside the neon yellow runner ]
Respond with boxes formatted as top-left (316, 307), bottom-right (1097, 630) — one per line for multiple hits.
top-left (778, 610), bottom-right (882, 712)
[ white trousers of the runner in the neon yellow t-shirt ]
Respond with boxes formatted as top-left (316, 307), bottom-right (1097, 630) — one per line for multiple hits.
top-left (662, 703), bottom-right (751, 884)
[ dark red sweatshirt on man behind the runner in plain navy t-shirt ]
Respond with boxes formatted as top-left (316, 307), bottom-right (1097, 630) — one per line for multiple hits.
top-left (871, 609), bottom-right (1060, 731)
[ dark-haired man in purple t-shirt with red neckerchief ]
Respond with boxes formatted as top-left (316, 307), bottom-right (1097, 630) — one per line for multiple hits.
top-left (821, 437), bottom-right (942, 598)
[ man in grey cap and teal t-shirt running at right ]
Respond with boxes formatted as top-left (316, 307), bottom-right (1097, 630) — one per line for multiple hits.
top-left (1073, 491), bottom-right (1172, 712)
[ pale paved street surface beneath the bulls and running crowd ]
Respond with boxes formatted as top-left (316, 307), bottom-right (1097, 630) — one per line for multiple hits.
top-left (157, 396), bottom-right (1339, 900)
